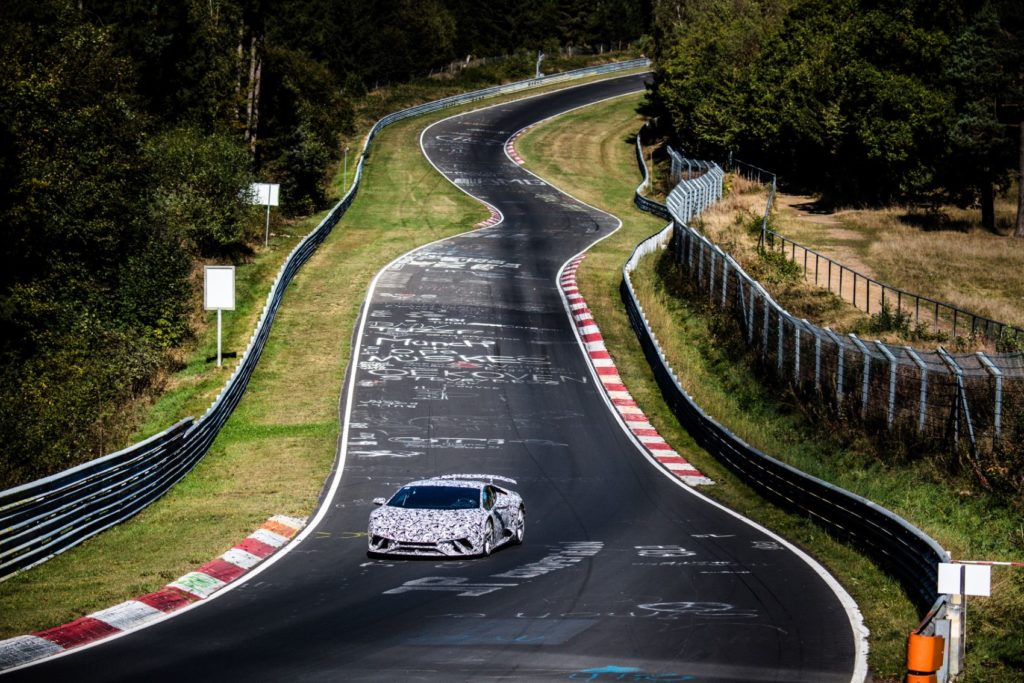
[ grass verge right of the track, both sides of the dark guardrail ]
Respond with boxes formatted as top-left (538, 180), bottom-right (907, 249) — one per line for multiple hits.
top-left (518, 97), bottom-right (1024, 681)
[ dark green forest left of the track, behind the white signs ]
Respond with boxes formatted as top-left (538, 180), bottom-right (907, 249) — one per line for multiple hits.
top-left (0, 0), bottom-right (650, 488)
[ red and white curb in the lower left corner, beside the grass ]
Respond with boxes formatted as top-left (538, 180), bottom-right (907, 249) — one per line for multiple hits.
top-left (0, 515), bottom-right (305, 671)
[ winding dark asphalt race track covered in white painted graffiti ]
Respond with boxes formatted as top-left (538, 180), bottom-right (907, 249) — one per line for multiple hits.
top-left (9, 76), bottom-right (864, 683)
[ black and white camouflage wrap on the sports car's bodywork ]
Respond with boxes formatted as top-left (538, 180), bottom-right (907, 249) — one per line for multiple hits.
top-left (367, 475), bottom-right (526, 557)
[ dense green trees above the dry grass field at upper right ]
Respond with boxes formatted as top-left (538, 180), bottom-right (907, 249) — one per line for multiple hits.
top-left (653, 0), bottom-right (1024, 229)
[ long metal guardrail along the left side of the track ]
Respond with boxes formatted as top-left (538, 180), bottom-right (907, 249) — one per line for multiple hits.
top-left (0, 59), bottom-right (650, 581)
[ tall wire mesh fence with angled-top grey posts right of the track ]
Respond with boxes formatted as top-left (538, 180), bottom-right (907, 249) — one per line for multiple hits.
top-left (668, 154), bottom-right (1024, 459)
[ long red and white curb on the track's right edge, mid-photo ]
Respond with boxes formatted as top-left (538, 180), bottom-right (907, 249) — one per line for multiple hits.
top-left (559, 254), bottom-right (715, 486)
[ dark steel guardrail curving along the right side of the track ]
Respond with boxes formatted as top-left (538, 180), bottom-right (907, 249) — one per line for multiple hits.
top-left (621, 131), bottom-right (949, 613)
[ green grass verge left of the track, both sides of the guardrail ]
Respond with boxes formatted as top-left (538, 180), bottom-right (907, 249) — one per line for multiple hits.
top-left (0, 61), bottom-right (647, 638)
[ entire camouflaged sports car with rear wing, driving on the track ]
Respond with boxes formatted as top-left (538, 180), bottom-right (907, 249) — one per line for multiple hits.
top-left (368, 474), bottom-right (526, 557)
